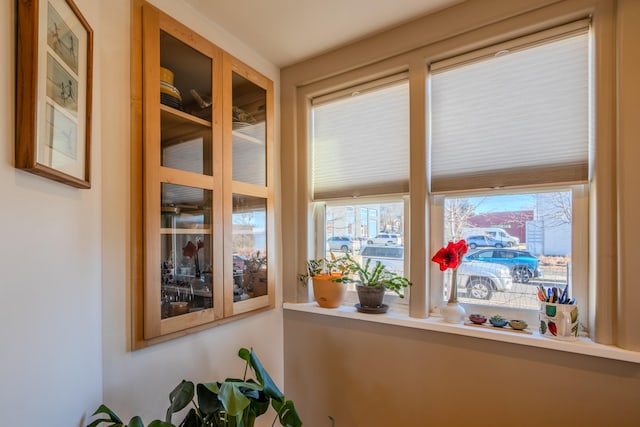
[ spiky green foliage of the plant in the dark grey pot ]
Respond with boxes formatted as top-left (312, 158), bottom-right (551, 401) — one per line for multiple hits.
top-left (336, 254), bottom-right (412, 298)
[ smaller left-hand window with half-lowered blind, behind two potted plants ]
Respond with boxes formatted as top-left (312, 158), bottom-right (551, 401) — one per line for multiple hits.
top-left (312, 75), bottom-right (409, 310)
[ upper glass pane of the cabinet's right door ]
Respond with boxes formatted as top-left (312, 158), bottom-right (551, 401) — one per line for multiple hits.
top-left (232, 73), bottom-right (267, 186)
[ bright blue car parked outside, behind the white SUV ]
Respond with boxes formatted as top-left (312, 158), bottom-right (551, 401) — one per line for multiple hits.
top-left (464, 249), bottom-right (542, 283)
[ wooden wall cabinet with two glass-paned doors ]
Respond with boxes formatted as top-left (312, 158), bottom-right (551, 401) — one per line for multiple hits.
top-left (132, 2), bottom-right (275, 347)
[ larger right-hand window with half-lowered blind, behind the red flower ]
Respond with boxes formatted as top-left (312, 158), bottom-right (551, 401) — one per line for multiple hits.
top-left (429, 22), bottom-right (590, 329)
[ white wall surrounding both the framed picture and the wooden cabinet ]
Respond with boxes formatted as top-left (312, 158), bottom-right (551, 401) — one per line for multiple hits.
top-left (0, 0), bottom-right (284, 427)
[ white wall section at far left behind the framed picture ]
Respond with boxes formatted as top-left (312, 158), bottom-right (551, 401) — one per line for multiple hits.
top-left (0, 0), bottom-right (103, 427)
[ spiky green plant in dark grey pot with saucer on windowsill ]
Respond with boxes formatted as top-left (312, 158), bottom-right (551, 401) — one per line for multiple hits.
top-left (337, 254), bottom-right (412, 313)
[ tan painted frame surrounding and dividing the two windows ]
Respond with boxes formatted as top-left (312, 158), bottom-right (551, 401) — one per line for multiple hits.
top-left (281, 0), bottom-right (620, 345)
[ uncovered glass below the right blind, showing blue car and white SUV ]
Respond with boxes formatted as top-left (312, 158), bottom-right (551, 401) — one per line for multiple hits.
top-left (443, 191), bottom-right (572, 310)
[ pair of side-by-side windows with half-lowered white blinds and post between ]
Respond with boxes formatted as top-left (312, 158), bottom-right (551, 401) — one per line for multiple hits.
top-left (298, 20), bottom-right (593, 323)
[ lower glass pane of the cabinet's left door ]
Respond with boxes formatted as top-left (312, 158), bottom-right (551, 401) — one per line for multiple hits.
top-left (160, 183), bottom-right (213, 319)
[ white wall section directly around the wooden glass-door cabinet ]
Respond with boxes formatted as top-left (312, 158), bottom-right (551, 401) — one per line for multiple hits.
top-left (99, 0), bottom-right (284, 425)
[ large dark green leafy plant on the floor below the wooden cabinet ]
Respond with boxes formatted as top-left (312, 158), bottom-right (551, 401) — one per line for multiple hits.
top-left (87, 348), bottom-right (302, 427)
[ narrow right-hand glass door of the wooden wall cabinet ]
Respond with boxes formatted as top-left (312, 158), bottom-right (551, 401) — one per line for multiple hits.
top-left (223, 55), bottom-right (275, 315)
